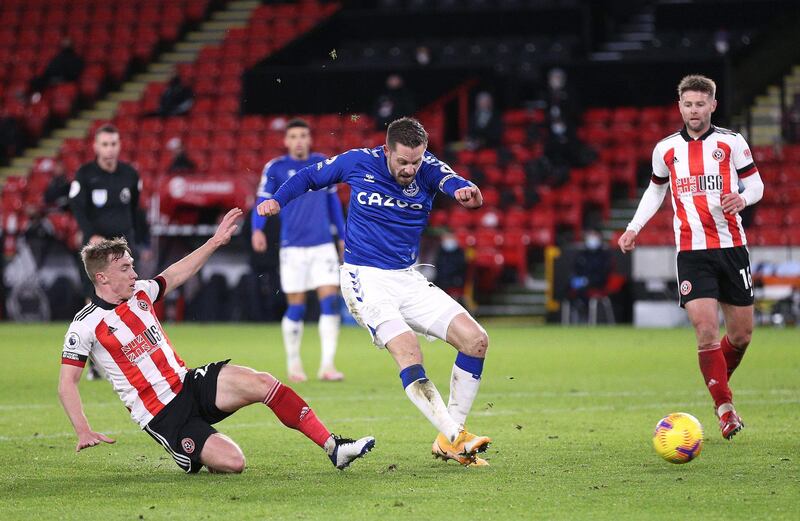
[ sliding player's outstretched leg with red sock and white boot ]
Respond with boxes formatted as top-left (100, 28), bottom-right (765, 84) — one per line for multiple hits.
top-left (216, 365), bottom-right (375, 469)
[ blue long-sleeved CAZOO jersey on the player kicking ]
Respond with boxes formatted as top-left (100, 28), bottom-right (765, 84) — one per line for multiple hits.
top-left (274, 147), bottom-right (471, 269)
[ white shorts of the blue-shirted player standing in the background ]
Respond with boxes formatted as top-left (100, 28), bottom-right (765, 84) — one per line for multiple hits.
top-left (280, 242), bottom-right (339, 293)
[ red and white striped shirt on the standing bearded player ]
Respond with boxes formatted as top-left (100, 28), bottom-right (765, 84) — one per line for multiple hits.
top-left (652, 125), bottom-right (758, 251)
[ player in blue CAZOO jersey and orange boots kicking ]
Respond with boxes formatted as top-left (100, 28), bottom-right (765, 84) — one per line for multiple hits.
top-left (257, 118), bottom-right (491, 465)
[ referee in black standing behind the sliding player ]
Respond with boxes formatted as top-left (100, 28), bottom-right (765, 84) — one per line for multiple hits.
top-left (69, 125), bottom-right (150, 380)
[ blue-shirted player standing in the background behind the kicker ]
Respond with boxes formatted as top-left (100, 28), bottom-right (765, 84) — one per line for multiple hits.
top-left (252, 119), bottom-right (344, 382)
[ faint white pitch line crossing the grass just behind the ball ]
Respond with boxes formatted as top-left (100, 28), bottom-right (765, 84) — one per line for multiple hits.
top-left (0, 398), bottom-right (800, 443)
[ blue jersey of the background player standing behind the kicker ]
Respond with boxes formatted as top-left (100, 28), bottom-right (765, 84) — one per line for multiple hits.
top-left (253, 153), bottom-right (344, 247)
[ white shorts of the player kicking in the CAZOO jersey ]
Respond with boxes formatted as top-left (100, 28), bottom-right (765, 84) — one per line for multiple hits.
top-left (340, 264), bottom-right (467, 348)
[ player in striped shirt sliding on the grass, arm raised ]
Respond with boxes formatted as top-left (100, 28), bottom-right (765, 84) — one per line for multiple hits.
top-left (58, 208), bottom-right (375, 473)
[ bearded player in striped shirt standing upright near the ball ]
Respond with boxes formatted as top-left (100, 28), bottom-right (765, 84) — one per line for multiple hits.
top-left (619, 75), bottom-right (764, 439)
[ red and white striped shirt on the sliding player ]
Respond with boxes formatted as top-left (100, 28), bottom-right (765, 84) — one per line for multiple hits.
top-left (61, 277), bottom-right (187, 428)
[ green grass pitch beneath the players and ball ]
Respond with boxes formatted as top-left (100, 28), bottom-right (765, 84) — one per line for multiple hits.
top-left (0, 323), bottom-right (800, 521)
